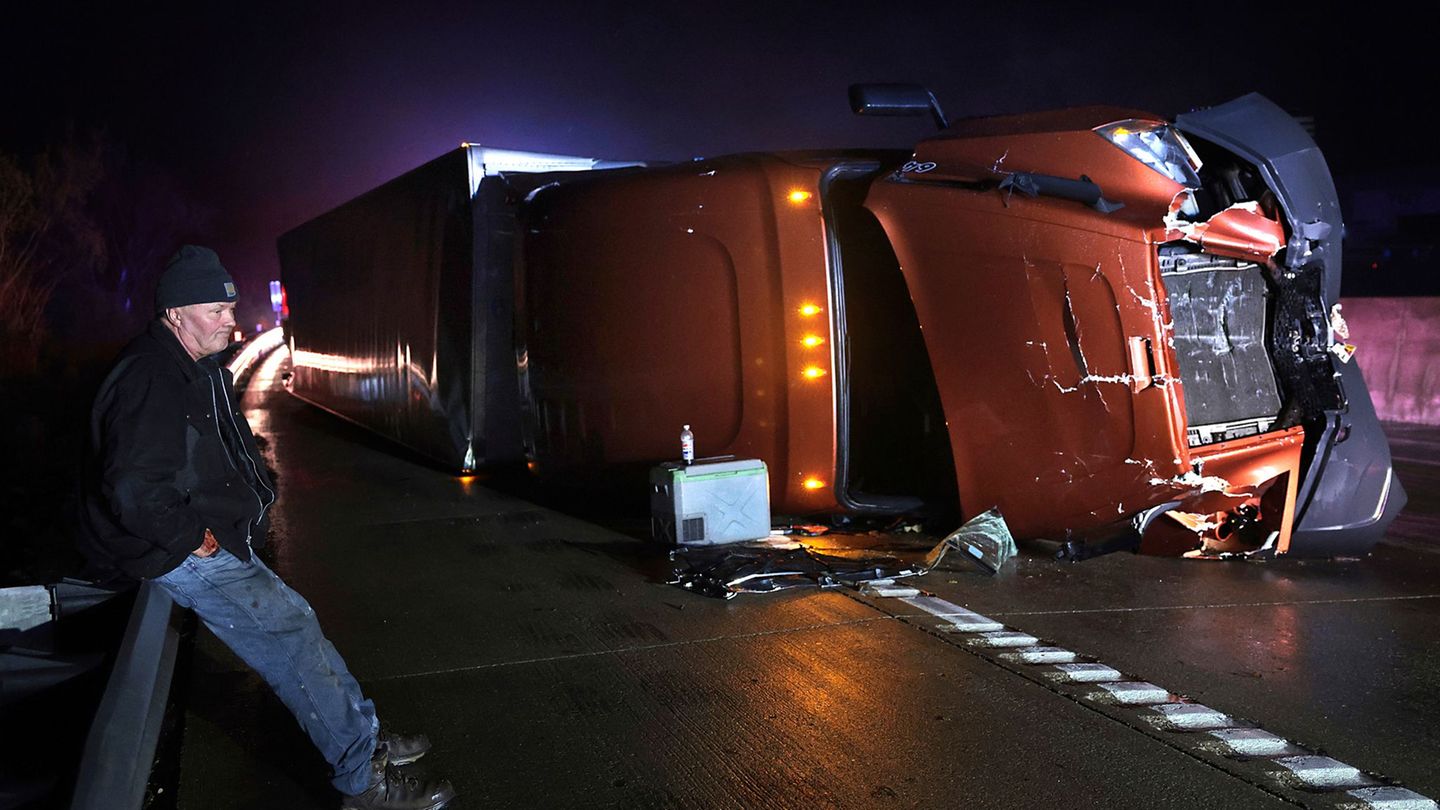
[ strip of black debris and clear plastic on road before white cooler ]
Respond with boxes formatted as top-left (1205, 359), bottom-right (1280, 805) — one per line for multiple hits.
top-left (670, 509), bottom-right (1015, 600)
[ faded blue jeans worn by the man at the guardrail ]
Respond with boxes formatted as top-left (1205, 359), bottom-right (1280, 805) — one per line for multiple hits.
top-left (156, 549), bottom-right (380, 796)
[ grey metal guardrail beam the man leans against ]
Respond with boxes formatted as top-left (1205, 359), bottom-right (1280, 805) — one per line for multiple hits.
top-left (71, 582), bottom-right (180, 810)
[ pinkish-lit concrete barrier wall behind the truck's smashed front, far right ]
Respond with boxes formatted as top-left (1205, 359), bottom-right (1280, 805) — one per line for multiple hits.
top-left (1341, 298), bottom-right (1440, 425)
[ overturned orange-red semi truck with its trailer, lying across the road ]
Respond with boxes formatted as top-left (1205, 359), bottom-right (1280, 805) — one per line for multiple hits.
top-left (278, 85), bottom-right (1405, 556)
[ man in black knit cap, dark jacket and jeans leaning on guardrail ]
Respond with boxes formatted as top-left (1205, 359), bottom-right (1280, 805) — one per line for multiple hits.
top-left (79, 245), bottom-right (455, 810)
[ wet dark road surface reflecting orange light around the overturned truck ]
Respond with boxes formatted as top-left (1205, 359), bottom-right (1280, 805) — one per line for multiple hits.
top-left (179, 353), bottom-right (1440, 810)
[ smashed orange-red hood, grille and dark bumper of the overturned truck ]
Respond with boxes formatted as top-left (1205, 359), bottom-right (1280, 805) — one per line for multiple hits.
top-left (867, 89), bottom-right (1404, 555)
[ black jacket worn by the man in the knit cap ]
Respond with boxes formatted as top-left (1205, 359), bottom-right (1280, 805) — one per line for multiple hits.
top-left (78, 321), bottom-right (275, 579)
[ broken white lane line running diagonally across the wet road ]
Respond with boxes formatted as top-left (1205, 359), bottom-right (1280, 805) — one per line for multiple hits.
top-left (869, 585), bottom-right (1440, 810)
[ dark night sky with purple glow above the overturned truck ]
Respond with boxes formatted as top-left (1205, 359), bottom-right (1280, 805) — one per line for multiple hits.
top-left (0, 1), bottom-right (1437, 323)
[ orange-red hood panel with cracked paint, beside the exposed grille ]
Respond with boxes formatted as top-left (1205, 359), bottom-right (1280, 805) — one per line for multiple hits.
top-left (867, 179), bottom-right (1187, 539)
